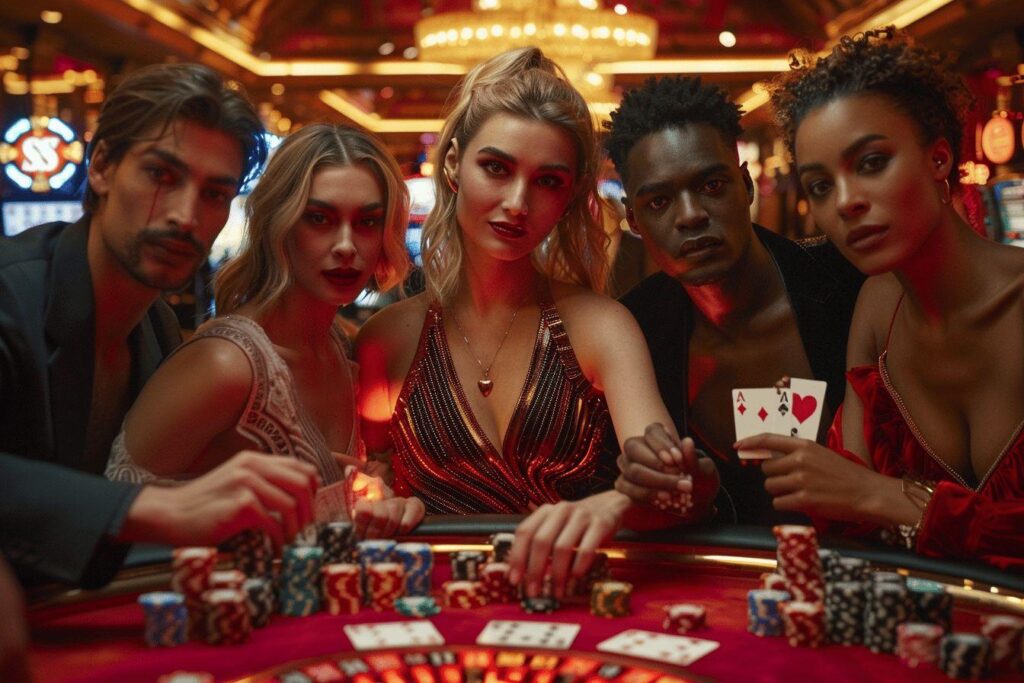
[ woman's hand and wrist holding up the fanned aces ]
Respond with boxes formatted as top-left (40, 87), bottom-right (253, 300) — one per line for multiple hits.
top-left (735, 434), bottom-right (900, 521)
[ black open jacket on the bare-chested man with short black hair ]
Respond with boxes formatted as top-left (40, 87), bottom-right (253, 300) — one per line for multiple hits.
top-left (615, 225), bottom-right (864, 524)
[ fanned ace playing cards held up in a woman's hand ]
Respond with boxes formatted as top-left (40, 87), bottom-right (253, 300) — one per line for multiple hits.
top-left (732, 379), bottom-right (827, 460)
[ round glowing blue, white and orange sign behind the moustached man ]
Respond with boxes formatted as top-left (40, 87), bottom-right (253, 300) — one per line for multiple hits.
top-left (0, 117), bottom-right (84, 193)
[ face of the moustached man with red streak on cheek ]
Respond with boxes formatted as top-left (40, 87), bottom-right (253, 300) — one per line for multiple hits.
top-left (89, 120), bottom-right (243, 290)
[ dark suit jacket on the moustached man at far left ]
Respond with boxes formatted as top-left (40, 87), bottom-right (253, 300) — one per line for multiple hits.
top-left (0, 215), bottom-right (181, 586)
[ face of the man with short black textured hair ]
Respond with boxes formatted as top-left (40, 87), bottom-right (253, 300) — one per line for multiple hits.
top-left (626, 123), bottom-right (754, 286)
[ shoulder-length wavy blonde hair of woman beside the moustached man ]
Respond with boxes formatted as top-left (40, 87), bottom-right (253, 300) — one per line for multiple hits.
top-left (214, 123), bottom-right (409, 314)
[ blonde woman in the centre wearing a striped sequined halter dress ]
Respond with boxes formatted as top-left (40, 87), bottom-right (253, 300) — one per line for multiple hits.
top-left (356, 48), bottom-right (717, 586)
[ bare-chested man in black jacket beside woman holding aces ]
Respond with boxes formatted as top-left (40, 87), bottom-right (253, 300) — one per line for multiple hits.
top-left (605, 78), bottom-right (862, 523)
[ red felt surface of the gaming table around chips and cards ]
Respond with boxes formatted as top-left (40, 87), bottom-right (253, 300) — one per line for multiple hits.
top-left (31, 544), bottom-right (1020, 683)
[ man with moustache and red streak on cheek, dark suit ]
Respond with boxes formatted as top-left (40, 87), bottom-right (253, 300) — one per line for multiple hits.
top-left (0, 65), bottom-right (316, 587)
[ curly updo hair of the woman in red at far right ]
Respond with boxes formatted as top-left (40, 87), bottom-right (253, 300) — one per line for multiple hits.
top-left (769, 27), bottom-right (973, 184)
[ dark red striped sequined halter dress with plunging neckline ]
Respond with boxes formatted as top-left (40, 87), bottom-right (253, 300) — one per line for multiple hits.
top-left (390, 293), bottom-right (617, 514)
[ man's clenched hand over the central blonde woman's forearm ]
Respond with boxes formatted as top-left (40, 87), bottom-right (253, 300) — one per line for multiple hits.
top-left (615, 424), bottom-right (719, 519)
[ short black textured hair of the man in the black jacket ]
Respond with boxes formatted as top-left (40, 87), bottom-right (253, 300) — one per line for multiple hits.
top-left (604, 76), bottom-right (743, 181)
